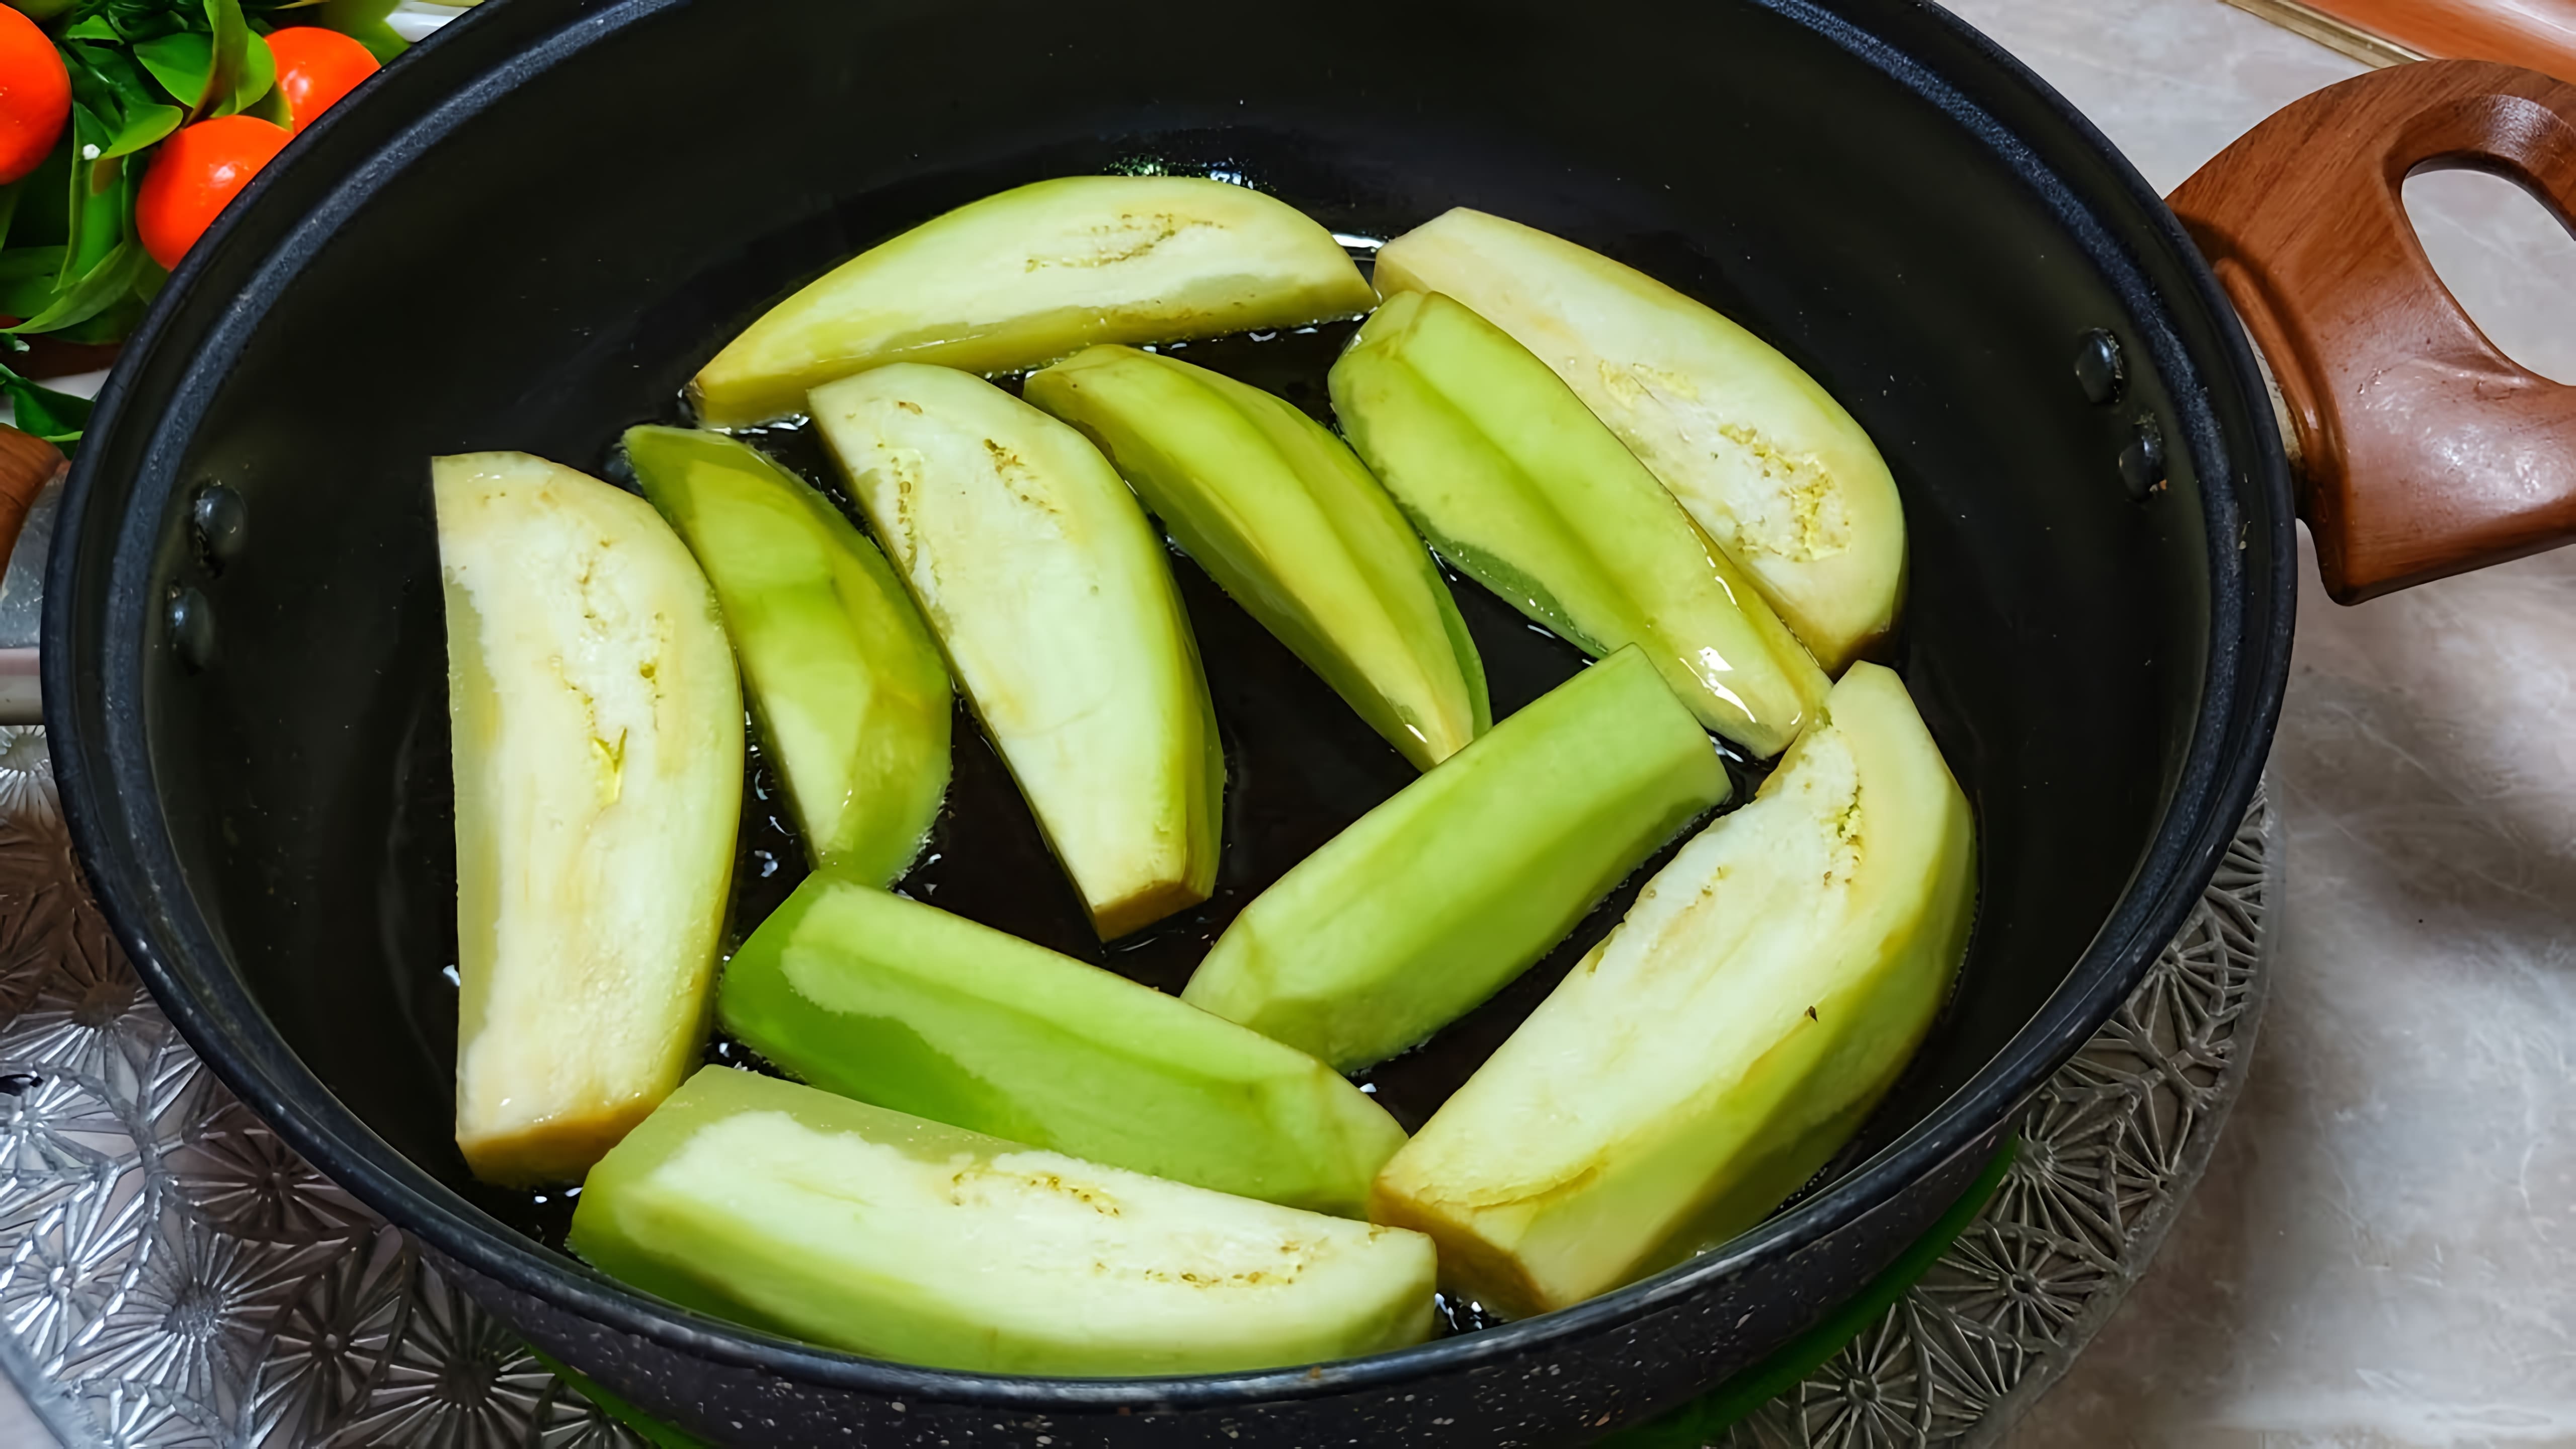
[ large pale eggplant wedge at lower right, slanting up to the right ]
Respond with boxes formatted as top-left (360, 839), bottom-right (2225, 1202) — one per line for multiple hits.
top-left (1371, 663), bottom-right (1976, 1315)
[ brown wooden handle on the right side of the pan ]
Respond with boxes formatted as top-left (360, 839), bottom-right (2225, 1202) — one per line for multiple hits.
top-left (2171, 59), bottom-right (2576, 603)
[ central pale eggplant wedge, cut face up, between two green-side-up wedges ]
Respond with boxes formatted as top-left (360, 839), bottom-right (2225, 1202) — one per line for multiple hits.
top-left (814, 364), bottom-right (1226, 941)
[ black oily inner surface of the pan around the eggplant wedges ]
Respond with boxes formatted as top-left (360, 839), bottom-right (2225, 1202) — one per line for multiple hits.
top-left (121, 0), bottom-right (2210, 1340)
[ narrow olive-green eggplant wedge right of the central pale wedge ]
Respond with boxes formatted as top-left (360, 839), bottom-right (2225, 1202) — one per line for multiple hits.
top-left (1023, 348), bottom-right (1494, 771)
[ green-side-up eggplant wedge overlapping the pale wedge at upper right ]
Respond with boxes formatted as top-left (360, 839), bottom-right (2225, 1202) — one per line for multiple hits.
top-left (1332, 291), bottom-right (1829, 758)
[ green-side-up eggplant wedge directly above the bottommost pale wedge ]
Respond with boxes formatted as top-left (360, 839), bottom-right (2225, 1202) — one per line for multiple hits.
top-left (716, 871), bottom-right (1404, 1217)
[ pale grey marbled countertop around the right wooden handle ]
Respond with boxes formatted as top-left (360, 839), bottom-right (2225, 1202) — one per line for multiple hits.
top-left (0, 0), bottom-right (2576, 1449)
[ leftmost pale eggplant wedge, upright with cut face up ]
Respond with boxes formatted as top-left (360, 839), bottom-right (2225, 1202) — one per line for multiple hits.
top-left (430, 454), bottom-right (742, 1186)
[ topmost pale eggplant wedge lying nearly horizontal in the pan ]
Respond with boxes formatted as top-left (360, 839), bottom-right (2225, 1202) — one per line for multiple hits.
top-left (690, 175), bottom-right (1376, 428)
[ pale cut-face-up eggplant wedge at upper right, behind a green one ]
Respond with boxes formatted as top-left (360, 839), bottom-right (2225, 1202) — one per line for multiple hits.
top-left (1378, 206), bottom-right (1906, 676)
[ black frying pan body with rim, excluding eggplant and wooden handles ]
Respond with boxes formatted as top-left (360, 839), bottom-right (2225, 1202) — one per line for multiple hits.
top-left (15, 0), bottom-right (2555, 1446)
